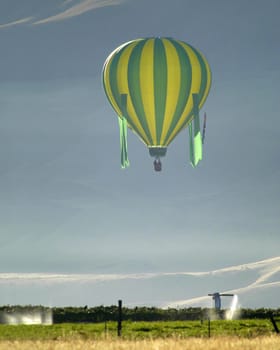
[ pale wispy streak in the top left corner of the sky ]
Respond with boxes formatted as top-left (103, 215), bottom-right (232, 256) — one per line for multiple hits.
top-left (0, 0), bottom-right (124, 29)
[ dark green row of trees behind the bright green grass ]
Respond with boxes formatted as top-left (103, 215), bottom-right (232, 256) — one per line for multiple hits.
top-left (0, 305), bottom-right (280, 323)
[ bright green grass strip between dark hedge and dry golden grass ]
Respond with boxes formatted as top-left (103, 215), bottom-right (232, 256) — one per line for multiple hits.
top-left (0, 319), bottom-right (274, 341)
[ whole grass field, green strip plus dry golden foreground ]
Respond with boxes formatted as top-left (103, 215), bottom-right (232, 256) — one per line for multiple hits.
top-left (0, 320), bottom-right (280, 350)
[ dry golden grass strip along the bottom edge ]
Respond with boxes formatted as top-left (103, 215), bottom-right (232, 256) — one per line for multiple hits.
top-left (0, 335), bottom-right (280, 350)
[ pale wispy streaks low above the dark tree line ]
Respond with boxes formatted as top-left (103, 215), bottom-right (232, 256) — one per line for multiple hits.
top-left (0, 256), bottom-right (280, 308)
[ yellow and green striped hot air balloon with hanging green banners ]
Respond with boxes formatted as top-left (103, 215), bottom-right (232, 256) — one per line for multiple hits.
top-left (102, 37), bottom-right (211, 171)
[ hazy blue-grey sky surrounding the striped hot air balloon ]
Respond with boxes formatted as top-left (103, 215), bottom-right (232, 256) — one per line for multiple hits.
top-left (0, 0), bottom-right (280, 306)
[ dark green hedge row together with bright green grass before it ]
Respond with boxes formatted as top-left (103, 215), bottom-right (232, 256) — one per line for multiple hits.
top-left (0, 306), bottom-right (280, 341)
